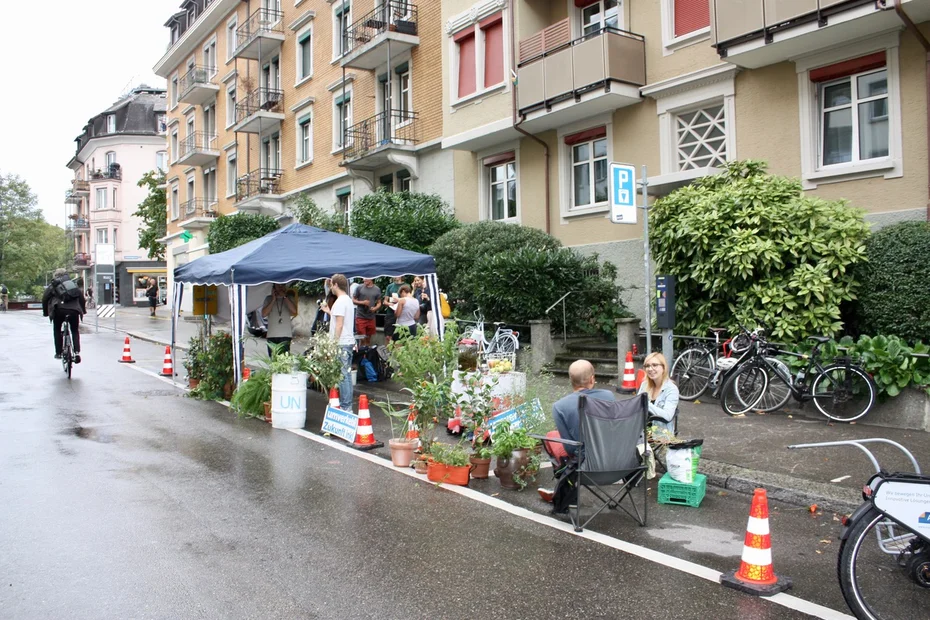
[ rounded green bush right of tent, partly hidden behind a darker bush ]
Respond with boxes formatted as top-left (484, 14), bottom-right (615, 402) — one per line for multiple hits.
top-left (429, 221), bottom-right (564, 306)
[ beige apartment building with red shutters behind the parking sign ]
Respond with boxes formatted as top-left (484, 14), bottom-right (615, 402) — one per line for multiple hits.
top-left (442, 0), bottom-right (930, 310)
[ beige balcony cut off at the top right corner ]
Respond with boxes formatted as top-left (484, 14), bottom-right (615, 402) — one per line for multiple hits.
top-left (710, 0), bottom-right (930, 69)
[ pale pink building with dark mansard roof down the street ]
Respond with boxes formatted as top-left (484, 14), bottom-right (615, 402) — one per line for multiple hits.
top-left (65, 86), bottom-right (167, 306)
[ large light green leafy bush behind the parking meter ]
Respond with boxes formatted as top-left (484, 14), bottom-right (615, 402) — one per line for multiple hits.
top-left (649, 161), bottom-right (869, 339)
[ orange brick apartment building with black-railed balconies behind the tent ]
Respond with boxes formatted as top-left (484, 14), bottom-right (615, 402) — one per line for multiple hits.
top-left (154, 0), bottom-right (454, 310)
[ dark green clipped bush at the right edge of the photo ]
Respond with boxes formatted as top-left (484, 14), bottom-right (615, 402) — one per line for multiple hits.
top-left (855, 222), bottom-right (930, 342)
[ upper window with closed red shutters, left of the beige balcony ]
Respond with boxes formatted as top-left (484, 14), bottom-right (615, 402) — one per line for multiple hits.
top-left (452, 13), bottom-right (505, 99)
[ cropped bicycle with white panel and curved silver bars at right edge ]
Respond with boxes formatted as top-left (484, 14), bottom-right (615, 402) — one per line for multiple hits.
top-left (788, 439), bottom-right (930, 620)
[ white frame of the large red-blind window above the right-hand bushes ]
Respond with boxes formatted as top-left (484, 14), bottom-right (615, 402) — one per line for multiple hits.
top-left (795, 31), bottom-right (904, 189)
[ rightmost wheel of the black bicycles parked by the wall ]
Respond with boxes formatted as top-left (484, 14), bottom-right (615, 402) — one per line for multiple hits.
top-left (811, 364), bottom-right (877, 422)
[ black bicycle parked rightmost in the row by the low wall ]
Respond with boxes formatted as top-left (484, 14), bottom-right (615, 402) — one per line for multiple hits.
top-left (720, 336), bottom-right (878, 422)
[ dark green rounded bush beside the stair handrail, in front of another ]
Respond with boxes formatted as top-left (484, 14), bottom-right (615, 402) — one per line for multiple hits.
top-left (464, 247), bottom-right (630, 335)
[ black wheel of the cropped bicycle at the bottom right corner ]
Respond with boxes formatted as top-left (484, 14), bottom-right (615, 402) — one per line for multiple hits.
top-left (836, 507), bottom-right (930, 620)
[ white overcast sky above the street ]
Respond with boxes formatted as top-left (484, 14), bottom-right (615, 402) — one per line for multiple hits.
top-left (0, 0), bottom-right (181, 226)
